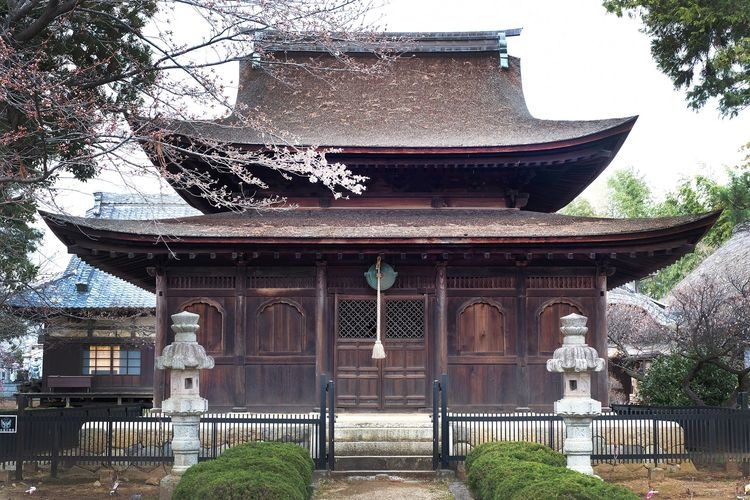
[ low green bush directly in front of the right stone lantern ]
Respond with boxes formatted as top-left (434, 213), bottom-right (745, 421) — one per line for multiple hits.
top-left (506, 469), bottom-right (640, 500)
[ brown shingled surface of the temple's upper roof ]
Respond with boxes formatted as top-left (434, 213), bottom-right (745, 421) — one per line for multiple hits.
top-left (163, 32), bottom-right (633, 148)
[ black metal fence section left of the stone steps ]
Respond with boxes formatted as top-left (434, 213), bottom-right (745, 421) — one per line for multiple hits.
top-left (0, 379), bottom-right (335, 480)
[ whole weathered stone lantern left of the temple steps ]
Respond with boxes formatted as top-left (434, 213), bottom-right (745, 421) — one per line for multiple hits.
top-left (155, 311), bottom-right (214, 500)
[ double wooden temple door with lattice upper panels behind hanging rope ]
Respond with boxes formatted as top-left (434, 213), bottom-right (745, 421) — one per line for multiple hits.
top-left (334, 296), bottom-right (429, 411)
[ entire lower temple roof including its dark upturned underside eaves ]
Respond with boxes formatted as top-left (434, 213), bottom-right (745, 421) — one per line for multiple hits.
top-left (42, 208), bottom-right (719, 289)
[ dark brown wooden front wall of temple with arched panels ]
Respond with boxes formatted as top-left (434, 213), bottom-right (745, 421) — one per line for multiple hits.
top-left (148, 257), bottom-right (607, 411)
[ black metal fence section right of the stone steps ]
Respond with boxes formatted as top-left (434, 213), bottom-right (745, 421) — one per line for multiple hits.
top-left (433, 375), bottom-right (750, 468)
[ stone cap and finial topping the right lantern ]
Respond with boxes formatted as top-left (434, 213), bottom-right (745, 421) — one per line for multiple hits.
top-left (547, 314), bottom-right (604, 373)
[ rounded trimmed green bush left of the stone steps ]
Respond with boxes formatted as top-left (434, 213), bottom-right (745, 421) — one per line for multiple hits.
top-left (172, 442), bottom-right (313, 500)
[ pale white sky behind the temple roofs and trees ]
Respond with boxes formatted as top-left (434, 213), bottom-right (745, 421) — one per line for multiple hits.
top-left (35, 0), bottom-right (750, 272)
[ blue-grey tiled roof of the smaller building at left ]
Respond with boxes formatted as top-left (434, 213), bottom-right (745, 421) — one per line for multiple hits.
top-left (10, 193), bottom-right (199, 309)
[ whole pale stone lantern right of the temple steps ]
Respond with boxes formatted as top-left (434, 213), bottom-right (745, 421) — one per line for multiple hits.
top-left (547, 314), bottom-right (604, 475)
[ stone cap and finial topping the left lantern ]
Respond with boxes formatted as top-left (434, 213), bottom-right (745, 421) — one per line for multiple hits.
top-left (155, 311), bottom-right (214, 370)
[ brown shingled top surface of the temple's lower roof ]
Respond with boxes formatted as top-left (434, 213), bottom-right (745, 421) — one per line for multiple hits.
top-left (43, 208), bottom-right (724, 241)
